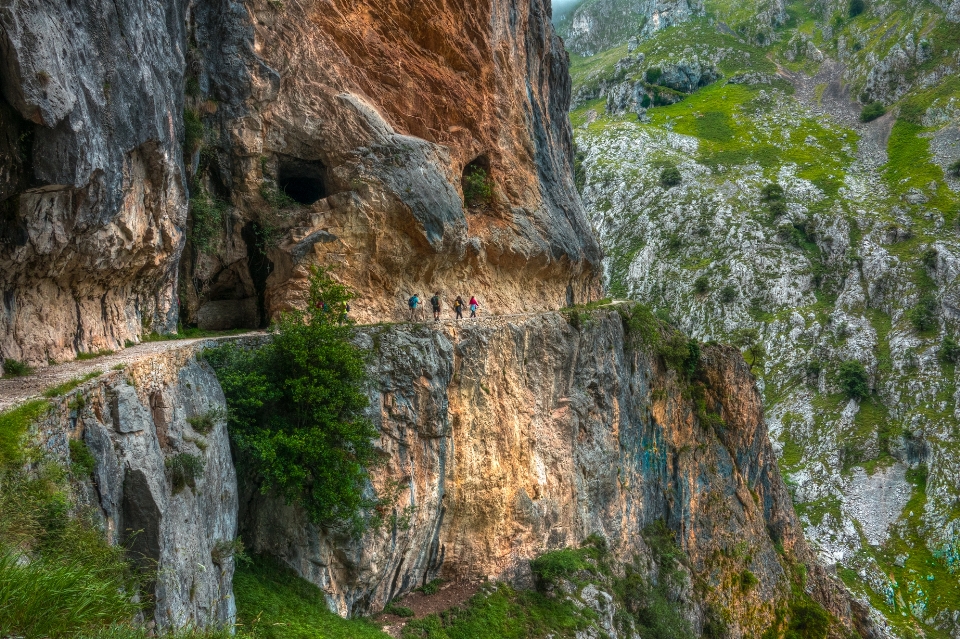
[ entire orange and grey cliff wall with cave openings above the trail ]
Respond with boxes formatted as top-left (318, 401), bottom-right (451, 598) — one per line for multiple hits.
top-left (0, 0), bottom-right (600, 364)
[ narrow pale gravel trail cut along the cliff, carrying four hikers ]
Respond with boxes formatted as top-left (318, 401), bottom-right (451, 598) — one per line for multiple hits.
top-left (0, 300), bottom-right (623, 412)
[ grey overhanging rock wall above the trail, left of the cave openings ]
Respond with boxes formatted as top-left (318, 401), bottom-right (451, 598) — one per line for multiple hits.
top-left (0, 0), bottom-right (186, 364)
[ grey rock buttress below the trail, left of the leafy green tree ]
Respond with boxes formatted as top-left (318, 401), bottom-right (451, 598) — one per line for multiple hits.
top-left (39, 348), bottom-right (237, 628)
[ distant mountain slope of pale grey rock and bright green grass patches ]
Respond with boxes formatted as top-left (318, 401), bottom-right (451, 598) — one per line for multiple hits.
top-left (572, 2), bottom-right (960, 636)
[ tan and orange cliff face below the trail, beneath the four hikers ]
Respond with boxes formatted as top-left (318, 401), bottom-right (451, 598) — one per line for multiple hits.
top-left (241, 311), bottom-right (850, 637)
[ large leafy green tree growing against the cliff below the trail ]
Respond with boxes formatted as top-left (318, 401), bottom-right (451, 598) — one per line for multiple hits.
top-left (205, 269), bottom-right (379, 530)
